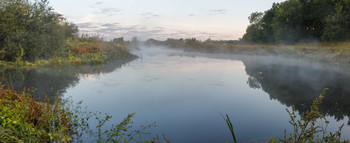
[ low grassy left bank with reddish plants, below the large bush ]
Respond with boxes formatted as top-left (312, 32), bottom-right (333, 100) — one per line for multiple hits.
top-left (0, 36), bottom-right (136, 70)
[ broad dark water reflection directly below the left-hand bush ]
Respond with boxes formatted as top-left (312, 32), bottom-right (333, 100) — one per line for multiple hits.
top-left (5, 68), bottom-right (79, 99)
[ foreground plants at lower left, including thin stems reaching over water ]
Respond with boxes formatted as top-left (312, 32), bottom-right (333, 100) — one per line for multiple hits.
top-left (0, 78), bottom-right (155, 143)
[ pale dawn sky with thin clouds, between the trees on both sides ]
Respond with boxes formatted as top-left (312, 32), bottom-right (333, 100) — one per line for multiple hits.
top-left (50, 0), bottom-right (285, 40)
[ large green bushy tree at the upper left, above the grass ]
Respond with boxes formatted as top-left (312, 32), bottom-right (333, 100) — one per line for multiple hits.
top-left (0, 0), bottom-right (78, 61)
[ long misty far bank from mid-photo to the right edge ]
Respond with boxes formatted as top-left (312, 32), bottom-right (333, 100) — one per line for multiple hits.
top-left (145, 38), bottom-right (350, 64)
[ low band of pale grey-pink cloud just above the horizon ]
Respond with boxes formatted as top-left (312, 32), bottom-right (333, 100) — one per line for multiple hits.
top-left (77, 22), bottom-right (234, 40)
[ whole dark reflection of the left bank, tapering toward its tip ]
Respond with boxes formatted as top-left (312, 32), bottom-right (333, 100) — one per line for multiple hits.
top-left (5, 60), bottom-right (135, 100)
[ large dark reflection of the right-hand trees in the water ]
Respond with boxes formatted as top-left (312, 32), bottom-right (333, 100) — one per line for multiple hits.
top-left (243, 58), bottom-right (350, 125)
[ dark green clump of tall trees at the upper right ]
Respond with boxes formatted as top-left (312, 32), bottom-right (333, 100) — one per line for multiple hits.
top-left (242, 0), bottom-right (350, 44)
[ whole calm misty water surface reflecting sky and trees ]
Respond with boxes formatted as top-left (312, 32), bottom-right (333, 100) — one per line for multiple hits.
top-left (6, 48), bottom-right (350, 143)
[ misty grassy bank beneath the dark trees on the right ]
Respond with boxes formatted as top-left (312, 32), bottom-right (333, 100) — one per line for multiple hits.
top-left (227, 42), bottom-right (350, 64)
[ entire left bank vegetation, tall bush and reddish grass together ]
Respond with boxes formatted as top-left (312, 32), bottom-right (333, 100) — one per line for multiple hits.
top-left (0, 0), bottom-right (132, 69)
